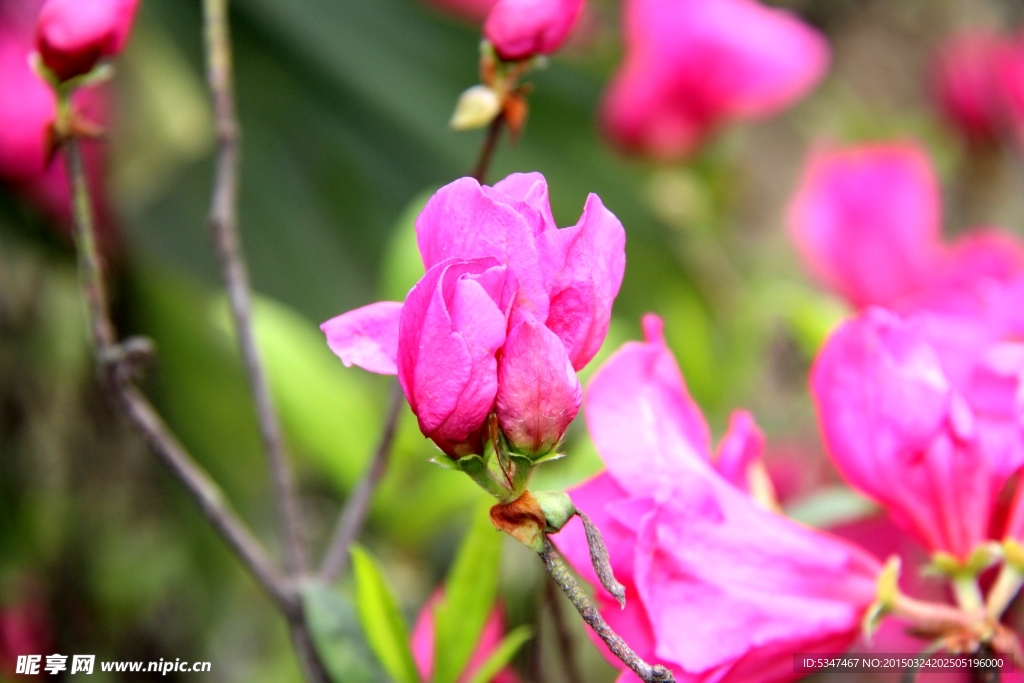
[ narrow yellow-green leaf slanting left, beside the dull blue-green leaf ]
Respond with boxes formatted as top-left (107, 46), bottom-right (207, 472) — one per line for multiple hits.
top-left (351, 546), bottom-right (420, 683)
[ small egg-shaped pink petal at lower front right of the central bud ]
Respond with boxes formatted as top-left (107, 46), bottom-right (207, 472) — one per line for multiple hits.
top-left (498, 321), bottom-right (583, 455)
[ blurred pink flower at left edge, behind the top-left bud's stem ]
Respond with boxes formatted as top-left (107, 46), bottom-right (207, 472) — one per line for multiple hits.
top-left (0, 0), bottom-right (120, 258)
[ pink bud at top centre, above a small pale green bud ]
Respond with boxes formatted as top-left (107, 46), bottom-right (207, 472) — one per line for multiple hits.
top-left (483, 0), bottom-right (584, 61)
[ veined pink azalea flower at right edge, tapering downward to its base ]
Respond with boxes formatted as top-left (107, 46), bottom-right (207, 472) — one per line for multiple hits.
top-left (811, 301), bottom-right (1024, 560)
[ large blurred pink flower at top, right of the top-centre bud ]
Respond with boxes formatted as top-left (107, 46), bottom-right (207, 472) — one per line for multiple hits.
top-left (602, 0), bottom-right (829, 159)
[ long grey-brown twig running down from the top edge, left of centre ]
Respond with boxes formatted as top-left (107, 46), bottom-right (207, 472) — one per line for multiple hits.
top-left (203, 0), bottom-right (305, 575)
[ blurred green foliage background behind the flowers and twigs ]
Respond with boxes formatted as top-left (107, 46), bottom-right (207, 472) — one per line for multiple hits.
top-left (0, 0), bottom-right (1024, 682)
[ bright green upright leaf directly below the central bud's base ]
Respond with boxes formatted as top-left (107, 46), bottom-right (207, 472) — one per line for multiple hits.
top-left (433, 502), bottom-right (504, 683)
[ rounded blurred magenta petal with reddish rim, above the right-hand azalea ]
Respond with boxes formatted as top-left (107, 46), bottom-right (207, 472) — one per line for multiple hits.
top-left (787, 143), bottom-right (941, 306)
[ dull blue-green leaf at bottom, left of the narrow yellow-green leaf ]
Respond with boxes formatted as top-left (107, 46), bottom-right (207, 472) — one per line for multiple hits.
top-left (302, 583), bottom-right (383, 683)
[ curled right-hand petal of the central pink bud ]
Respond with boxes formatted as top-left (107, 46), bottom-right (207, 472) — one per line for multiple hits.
top-left (542, 195), bottom-right (626, 370)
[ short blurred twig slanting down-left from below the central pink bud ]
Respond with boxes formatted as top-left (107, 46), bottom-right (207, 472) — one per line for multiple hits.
top-left (321, 382), bottom-right (406, 584)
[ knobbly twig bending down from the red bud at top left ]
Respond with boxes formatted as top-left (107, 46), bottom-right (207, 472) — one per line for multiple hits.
top-left (66, 139), bottom-right (299, 615)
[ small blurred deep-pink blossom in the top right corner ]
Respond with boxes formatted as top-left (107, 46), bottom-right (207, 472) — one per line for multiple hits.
top-left (932, 30), bottom-right (1009, 142)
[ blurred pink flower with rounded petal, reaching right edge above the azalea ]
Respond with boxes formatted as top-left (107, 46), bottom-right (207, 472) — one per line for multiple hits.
top-left (786, 142), bottom-right (1024, 308)
